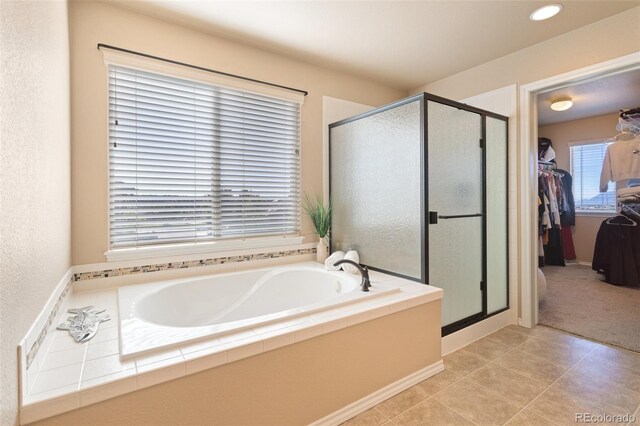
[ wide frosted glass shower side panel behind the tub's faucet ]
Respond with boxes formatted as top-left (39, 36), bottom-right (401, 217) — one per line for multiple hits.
top-left (329, 98), bottom-right (425, 280)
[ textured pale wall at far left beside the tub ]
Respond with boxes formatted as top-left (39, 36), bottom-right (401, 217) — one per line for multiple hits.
top-left (0, 1), bottom-right (71, 425)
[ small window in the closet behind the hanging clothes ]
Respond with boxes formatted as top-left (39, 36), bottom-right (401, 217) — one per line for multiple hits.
top-left (569, 141), bottom-right (616, 212)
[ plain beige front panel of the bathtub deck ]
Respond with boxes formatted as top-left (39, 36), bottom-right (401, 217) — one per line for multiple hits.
top-left (37, 301), bottom-right (440, 426)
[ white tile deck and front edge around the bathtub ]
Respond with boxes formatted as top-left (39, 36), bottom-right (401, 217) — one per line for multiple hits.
top-left (21, 264), bottom-right (442, 423)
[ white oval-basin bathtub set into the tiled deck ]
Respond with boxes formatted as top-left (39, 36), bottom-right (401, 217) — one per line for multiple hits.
top-left (118, 265), bottom-right (400, 357)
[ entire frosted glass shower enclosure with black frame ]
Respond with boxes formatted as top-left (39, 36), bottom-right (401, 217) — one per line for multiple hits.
top-left (329, 93), bottom-right (508, 335)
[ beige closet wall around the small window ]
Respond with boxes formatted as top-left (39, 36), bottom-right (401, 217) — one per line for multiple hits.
top-left (538, 113), bottom-right (618, 263)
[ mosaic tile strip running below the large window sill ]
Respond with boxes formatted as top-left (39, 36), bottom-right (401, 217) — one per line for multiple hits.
top-left (73, 248), bottom-right (316, 281)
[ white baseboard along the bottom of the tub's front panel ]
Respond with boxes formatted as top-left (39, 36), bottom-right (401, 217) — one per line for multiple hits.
top-left (311, 360), bottom-right (444, 426)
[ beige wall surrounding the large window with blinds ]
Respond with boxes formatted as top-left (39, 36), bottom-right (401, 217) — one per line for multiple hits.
top-left (69, 1), bottom-right (407, 264)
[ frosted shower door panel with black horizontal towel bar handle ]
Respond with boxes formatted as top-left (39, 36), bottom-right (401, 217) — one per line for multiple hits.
top-left (427, 100), bottom-right (484, 327)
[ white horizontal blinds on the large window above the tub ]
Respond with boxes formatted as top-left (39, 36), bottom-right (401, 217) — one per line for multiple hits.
top-left (109, 65), bottom-right (300, 249)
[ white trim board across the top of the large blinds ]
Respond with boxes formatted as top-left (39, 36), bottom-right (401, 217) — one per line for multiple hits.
top-left (100, 47), bottom-right (304, 105)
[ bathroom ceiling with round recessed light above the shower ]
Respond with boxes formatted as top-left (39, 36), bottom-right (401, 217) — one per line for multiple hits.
top-left (110, 0), bottom-right (640, 90)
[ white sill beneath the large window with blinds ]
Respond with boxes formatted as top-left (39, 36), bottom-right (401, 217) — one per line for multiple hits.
top-left (105, 235), bottom-right (304, 262)
